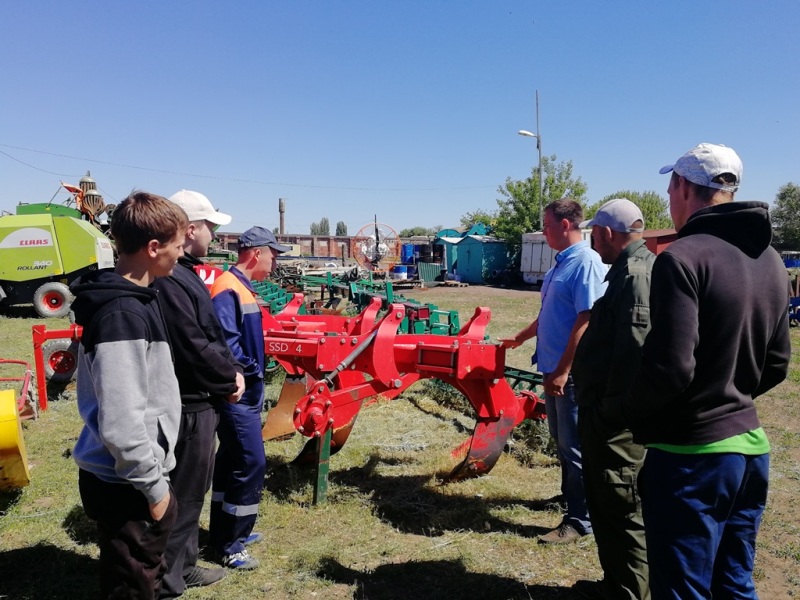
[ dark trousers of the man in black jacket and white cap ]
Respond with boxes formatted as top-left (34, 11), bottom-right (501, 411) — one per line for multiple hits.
top-left (160, 408), bottom-right (219, 598)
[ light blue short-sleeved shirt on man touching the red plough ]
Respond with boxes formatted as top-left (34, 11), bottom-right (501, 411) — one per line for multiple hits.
top-left (531, 241), bottom-right (608, 373)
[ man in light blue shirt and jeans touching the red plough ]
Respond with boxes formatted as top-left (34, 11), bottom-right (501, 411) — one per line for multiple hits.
top-left (500, 198), bottom-right (607, 544)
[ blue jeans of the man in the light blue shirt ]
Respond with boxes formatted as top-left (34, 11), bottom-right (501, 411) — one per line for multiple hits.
top-left (543, 375), bottom-right (592, 534)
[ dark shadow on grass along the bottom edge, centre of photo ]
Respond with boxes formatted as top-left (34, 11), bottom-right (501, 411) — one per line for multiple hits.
top-left (317, 558), bottom-right (571, 600)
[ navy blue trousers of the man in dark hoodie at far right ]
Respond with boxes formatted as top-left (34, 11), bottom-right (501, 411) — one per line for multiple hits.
top-left (640, 448), bottom-right (769, 600)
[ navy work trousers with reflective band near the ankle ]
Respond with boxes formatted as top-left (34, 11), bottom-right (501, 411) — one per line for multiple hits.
top-left (209, 382), bottom-right (267, 556)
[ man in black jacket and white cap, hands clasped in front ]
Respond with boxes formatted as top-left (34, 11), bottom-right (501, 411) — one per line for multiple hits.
top-left (153, 190), bottom-right (244, 598)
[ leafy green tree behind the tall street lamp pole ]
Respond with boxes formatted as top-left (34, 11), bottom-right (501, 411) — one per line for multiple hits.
top-left (494, 154), bottom-right (588, 255)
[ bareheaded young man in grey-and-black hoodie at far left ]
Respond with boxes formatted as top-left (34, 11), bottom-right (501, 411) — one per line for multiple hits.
top-left (72, 192), bottom-right (187, 599)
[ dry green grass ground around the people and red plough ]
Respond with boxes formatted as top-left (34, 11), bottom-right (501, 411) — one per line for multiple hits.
top-left (0, 287), bottom-right (800, 600)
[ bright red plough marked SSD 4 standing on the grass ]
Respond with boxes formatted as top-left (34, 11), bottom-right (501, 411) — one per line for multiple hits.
top-left (262, 294), bottom-right (544, 481)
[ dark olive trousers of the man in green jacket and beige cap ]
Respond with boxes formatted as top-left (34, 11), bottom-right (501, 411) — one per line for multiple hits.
top-left (578, 406), bottom-right (650, 600)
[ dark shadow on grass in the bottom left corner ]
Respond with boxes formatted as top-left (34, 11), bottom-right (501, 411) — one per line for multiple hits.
top-left (0, 542), bottom-right (98, 600)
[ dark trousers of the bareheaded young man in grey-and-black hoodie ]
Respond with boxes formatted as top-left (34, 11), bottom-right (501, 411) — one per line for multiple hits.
top-left (78, 469), bottom-right (178, 600)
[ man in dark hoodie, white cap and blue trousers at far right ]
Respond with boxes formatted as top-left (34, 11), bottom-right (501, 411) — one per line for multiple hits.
top-left (594, 144), bottom-right (791, 600)
